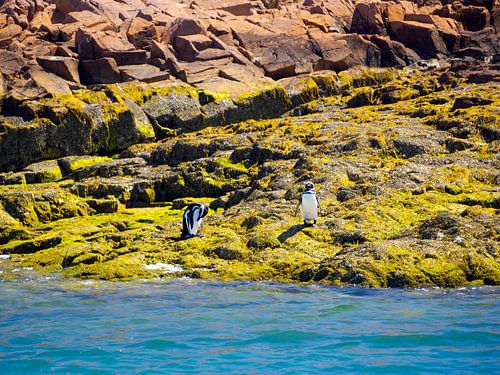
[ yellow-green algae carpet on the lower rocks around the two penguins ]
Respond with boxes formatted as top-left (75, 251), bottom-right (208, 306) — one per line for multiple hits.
top-left (0, 70), bottom-right (500, 287)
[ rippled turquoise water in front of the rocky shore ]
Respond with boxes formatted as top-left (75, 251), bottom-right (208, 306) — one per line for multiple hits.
top-left (0, 280), bottom-right (500, 374)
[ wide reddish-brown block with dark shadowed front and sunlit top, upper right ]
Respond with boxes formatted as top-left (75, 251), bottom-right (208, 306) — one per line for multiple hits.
top-left (389, 21), bottom-right (447, 57)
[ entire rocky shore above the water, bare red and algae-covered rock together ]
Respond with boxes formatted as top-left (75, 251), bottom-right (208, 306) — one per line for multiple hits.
top-left (0, 0), bottom-right (500, 287)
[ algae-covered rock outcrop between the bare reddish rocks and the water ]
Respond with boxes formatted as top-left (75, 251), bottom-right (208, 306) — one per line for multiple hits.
top-left (0, 64), bottom-right (500, 287)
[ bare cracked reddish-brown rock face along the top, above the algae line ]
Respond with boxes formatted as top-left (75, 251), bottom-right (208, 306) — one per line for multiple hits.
top-left (0, 0), bottom-right (498, 98)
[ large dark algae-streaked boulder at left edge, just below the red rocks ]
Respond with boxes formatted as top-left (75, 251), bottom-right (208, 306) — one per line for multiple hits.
top-left (0, 97), bottom-right (154, 171)
